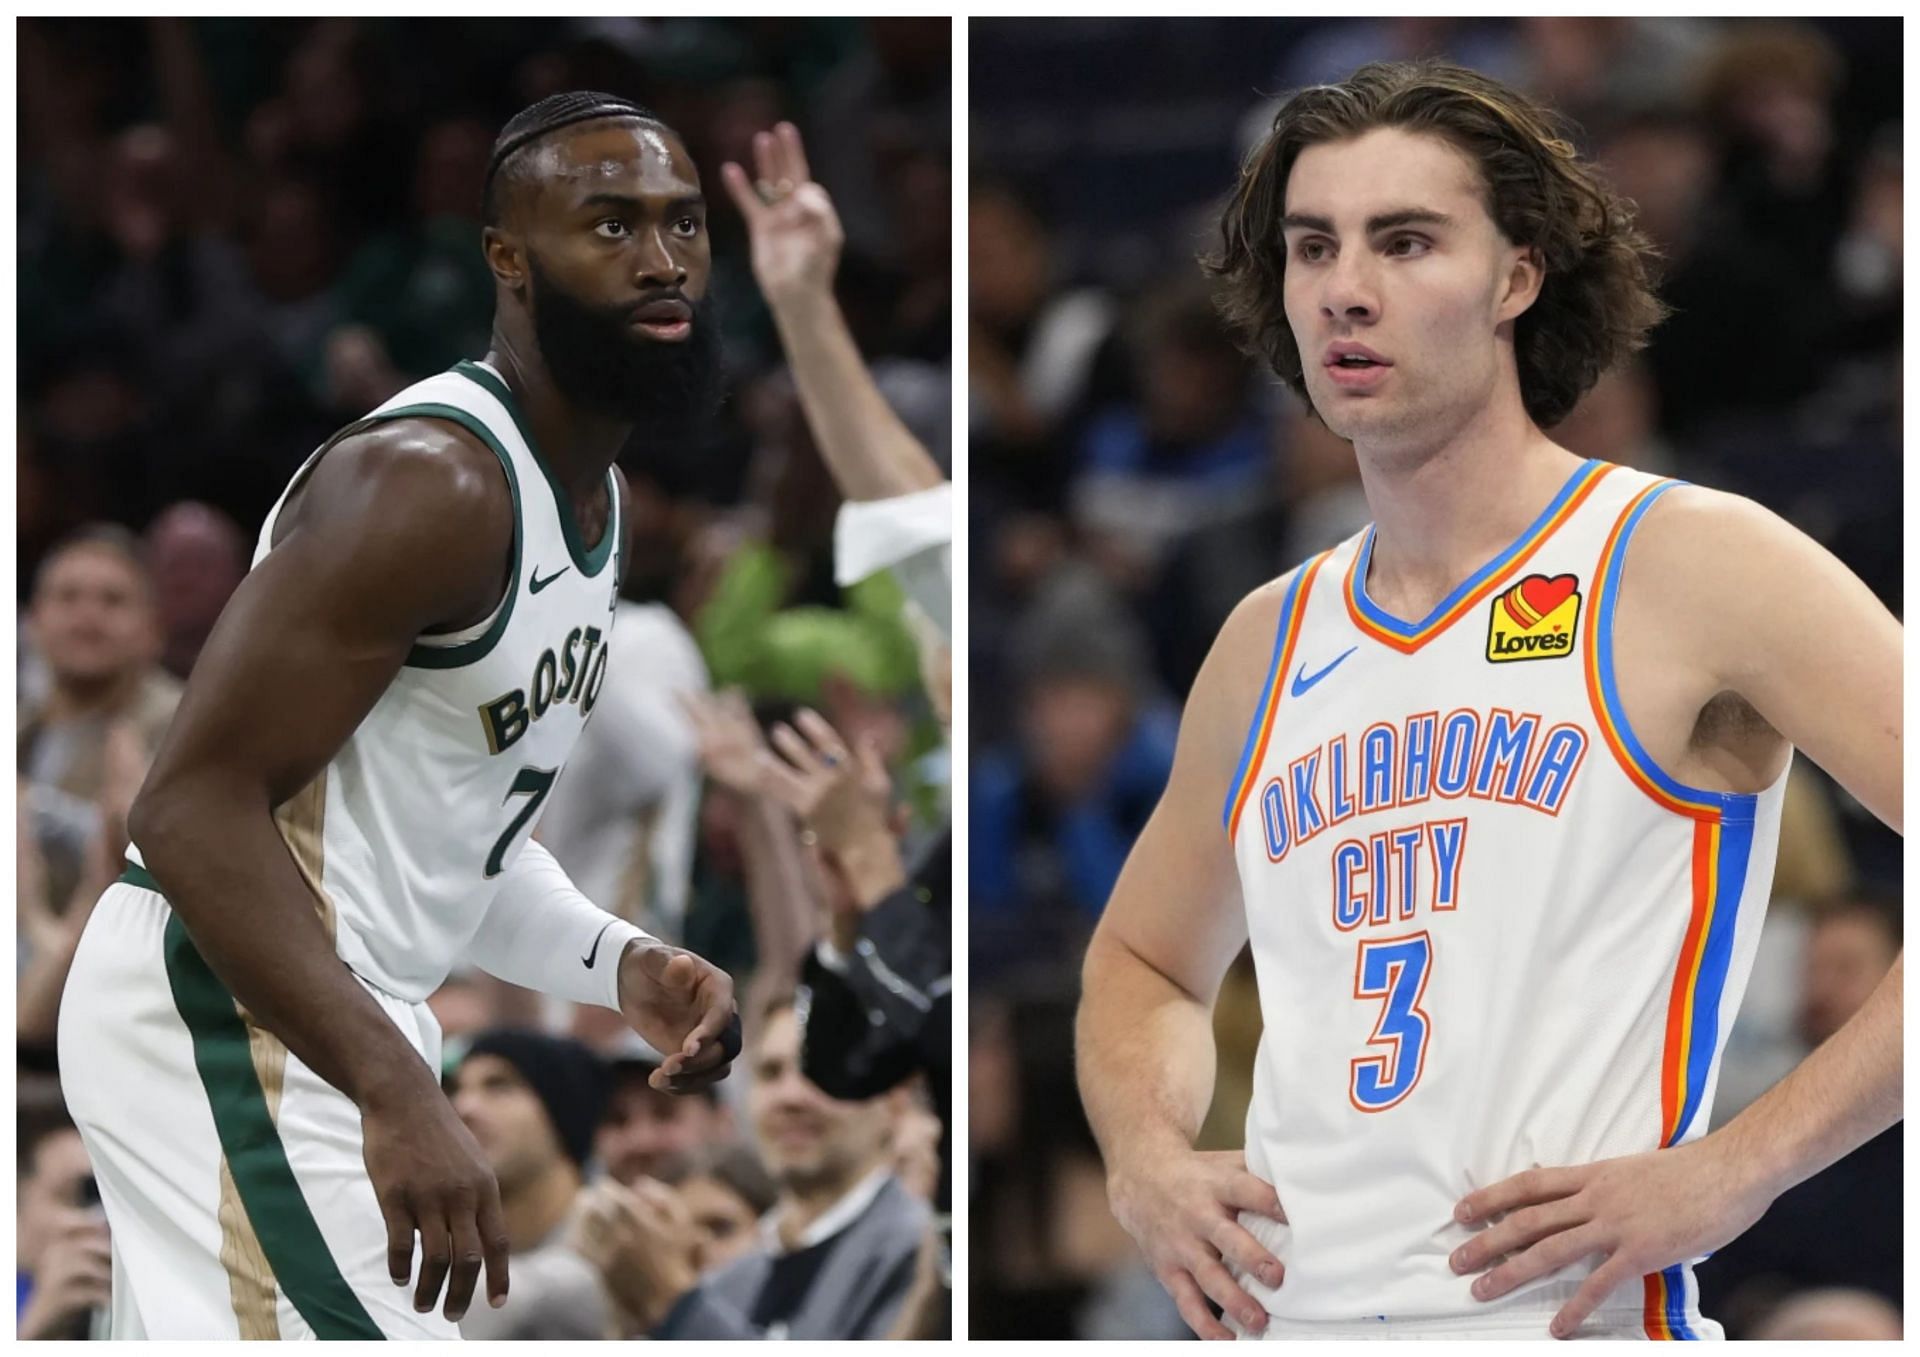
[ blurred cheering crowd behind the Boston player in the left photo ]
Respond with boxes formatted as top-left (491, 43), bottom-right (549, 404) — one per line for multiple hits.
top-left (17, 19), bottom-right (952, 1338)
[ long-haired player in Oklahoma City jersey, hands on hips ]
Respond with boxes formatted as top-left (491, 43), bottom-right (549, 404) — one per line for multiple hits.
top-left (1079, 65), bottom-right (1901, 1338)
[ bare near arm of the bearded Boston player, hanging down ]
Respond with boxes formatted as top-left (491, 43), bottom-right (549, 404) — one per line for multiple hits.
top-left (129, 420), bottom-right (513, 1319)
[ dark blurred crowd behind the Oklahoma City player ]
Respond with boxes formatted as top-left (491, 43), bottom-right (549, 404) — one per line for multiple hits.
top-left (968, 17), bottom-right (1903, 1338)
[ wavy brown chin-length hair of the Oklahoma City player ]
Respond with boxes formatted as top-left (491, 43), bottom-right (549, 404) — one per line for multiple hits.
top-left (1200, 61), bottom-right (1667, 428)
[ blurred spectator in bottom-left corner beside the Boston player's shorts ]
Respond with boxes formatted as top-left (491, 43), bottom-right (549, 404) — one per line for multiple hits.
top-left (13, 1111), bottom-right (113, 1338)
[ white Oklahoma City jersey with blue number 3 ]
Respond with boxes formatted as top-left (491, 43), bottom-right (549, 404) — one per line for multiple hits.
top-left (1225, 461), bottom-right (1786, 1338)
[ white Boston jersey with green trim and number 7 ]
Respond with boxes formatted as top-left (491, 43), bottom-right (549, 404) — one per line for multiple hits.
top-left (129, 363), bottom-right (622, 1002)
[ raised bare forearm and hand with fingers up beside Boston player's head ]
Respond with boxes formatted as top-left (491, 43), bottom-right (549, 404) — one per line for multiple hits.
top-left (720, 123), bottom-right (941, 499)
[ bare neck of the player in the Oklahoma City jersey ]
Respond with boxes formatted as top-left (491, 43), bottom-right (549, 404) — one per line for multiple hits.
top-left (1354, 399), bottom-right (1580, 618)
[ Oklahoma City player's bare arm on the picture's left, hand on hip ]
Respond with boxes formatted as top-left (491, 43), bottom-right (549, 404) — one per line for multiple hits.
top-left (1077, 580), bottom-right (1286, 1338)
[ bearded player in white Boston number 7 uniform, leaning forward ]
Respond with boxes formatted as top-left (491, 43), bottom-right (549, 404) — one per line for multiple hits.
top-left (60, 94), bottom-right (739, 1340)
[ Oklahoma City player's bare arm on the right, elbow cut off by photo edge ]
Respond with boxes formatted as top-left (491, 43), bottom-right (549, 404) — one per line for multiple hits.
top-left (1455, 488), bottom-right (1905, 1334)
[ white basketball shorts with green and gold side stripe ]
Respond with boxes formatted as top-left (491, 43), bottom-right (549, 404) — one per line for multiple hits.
top-left (60, 866), bottom-right (456, 1340)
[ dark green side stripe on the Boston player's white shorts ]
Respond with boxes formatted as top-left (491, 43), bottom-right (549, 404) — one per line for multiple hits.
top-left (161, 905), bottom-right (386, 1338)
